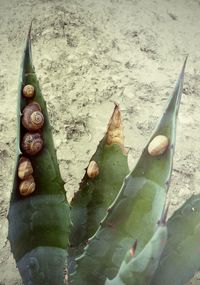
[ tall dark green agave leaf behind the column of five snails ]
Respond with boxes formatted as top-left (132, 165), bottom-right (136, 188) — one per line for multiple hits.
top-left (8, 25), bottom-right (70, 285)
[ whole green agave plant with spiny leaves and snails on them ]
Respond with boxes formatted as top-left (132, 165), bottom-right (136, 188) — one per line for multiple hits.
top-left (8, 25), bottom-right (200, 285)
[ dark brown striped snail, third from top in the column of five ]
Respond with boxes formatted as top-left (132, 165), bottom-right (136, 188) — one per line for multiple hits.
top-left (21, 132), bottom-right (43, 156)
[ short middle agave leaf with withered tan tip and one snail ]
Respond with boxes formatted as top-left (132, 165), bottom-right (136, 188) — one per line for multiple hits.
top-left (70, 105), bottom-right (129, 246)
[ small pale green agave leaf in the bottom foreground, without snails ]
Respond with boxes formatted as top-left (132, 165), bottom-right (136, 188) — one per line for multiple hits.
top-left (105, 206), bottom-right (167, 285)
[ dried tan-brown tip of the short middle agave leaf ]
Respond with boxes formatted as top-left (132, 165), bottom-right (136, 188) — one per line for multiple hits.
top-left (106, 104), bottom-right (125, 150)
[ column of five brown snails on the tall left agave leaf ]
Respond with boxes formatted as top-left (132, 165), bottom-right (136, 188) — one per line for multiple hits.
top-left (18, 85), bottom-right (44, 196)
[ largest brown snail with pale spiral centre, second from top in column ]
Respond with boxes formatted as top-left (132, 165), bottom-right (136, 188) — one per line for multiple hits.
top-left (22, 102), bottom-right (44, 131)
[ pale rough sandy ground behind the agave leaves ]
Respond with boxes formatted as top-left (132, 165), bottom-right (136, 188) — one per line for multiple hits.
top-left (0, 0), bottom-right (200, 285)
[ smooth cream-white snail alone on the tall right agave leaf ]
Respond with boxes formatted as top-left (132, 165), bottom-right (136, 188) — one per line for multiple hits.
top-left (148, 135), bottom-right (169, 156)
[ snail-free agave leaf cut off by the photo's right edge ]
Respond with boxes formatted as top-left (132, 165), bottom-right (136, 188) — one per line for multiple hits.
top-left (151, 195), bottom-right (200, 285)
